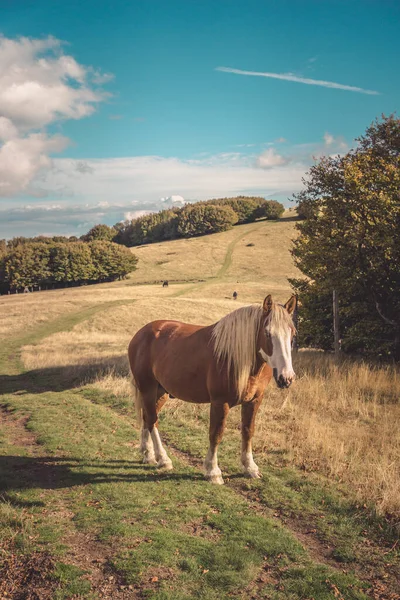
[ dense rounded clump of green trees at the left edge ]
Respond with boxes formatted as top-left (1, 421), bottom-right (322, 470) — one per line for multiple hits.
top-left (0, 237), bottom-right (137, 293)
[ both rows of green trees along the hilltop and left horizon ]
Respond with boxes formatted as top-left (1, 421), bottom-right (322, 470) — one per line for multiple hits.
top-left (0, 197), bottom-right (284, 293)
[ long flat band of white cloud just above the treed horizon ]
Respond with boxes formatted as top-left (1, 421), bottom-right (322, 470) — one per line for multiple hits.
top-left (0, 134), bottom-right (346, 238)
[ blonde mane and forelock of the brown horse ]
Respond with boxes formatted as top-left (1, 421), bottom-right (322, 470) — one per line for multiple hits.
top-left (211, 304), bottom-right (294, 398)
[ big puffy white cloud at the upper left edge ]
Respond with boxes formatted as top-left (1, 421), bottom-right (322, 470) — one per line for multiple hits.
top-left (0, 37), bottom-right (110, 196)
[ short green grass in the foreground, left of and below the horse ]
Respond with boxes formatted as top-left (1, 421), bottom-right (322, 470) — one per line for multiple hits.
top-left (0, 344), bottom-right (372, 599)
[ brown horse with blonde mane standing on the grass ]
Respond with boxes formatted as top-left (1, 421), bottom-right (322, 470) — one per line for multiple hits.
top-left (128, 296), bottom-right (296, 484)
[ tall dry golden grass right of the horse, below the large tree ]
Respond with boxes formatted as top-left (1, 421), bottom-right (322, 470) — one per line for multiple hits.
top-left (255, 352), bottom-right (400, 516)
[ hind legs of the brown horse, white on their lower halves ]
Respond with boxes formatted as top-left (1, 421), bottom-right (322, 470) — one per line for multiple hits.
top-left (142, 387), bottom-right (173, 470)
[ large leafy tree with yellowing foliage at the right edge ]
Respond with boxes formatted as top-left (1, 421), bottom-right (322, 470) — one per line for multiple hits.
top-left (293, 115), bottom-right (400, 359)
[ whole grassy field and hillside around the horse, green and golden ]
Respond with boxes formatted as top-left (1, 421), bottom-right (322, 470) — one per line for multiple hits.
top-left (0, 220), bottom-right (400, 600)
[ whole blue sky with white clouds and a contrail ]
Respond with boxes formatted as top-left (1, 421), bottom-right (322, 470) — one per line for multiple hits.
top-left (0, 0), bottom-right (400, 239)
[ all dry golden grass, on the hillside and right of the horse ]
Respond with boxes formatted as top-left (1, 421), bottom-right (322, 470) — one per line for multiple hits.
top-left (7, 222), bottom-right (400, 515)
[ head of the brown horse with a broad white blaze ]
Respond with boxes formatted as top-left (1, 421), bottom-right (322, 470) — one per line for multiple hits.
top-left (259, 295), bottom-right (297, 388)
